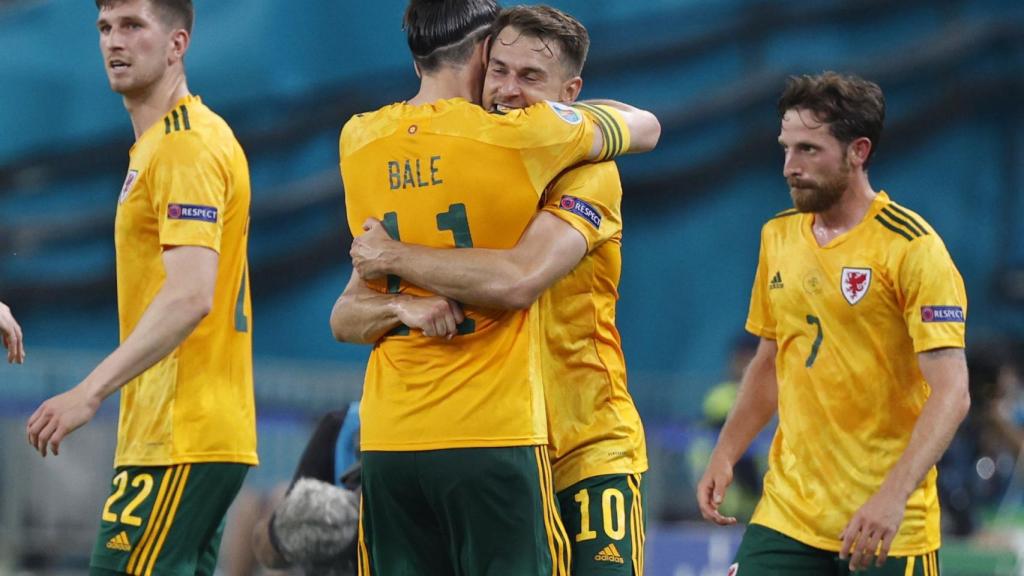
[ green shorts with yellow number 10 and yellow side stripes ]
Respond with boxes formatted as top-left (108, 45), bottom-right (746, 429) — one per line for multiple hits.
top-left (558, 474), bottom-right (647, 576)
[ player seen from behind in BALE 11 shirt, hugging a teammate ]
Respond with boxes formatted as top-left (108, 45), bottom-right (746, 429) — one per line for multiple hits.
top-left (331, 0), bottom-right (658, 576)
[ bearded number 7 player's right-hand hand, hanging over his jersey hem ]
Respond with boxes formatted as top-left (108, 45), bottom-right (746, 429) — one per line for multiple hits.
top-left (839, 487), bottom-right (906, 572)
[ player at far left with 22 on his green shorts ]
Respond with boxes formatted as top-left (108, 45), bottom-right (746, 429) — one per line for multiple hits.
top-left (28, 0), bottom-right (257, 575)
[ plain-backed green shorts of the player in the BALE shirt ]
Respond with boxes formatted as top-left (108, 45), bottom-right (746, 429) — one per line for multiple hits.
top-left (358, 446), bottom-right (569, 576)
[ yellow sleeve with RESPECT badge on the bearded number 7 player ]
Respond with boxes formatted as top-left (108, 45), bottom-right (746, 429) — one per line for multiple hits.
top-left (899, 234), bottom-right (967, 353)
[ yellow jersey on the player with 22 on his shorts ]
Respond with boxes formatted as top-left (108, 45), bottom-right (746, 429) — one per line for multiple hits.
top-left (115, 96), bottom-right (257, 466)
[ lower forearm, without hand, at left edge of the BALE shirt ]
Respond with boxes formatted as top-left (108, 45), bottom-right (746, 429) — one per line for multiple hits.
top-left (331, 281), bottom-right (412, 344)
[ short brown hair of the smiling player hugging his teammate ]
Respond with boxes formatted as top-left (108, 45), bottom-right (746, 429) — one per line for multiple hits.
top-left (490, 4), bottom-right (590, 76)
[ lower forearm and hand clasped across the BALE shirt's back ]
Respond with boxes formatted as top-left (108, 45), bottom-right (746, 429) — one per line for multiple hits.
top-left (331, 269), bottom-right (463, 344)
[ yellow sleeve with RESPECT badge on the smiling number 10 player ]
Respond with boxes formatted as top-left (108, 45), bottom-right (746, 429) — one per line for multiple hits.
top-left (542, 162), bottom-right (623, 252)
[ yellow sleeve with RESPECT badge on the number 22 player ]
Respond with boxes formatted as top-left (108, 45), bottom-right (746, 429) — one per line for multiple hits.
top-left (151, 133), bottom-right (230, 253)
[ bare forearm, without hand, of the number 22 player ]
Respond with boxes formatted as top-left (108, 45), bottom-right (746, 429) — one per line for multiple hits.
top-left (82, 288), bottom-right (209, 401)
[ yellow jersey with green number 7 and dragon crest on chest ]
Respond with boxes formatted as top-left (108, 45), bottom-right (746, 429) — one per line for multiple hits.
top-left (746, 192), bottom-right (967, 556)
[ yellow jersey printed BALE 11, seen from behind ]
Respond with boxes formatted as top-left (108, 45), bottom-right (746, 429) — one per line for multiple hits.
top-left (340, 98), bottom-right (628, 450)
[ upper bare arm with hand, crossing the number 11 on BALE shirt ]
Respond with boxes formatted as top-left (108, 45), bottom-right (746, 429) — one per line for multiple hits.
top-left (351, 211), bottom-right (587, 310)
